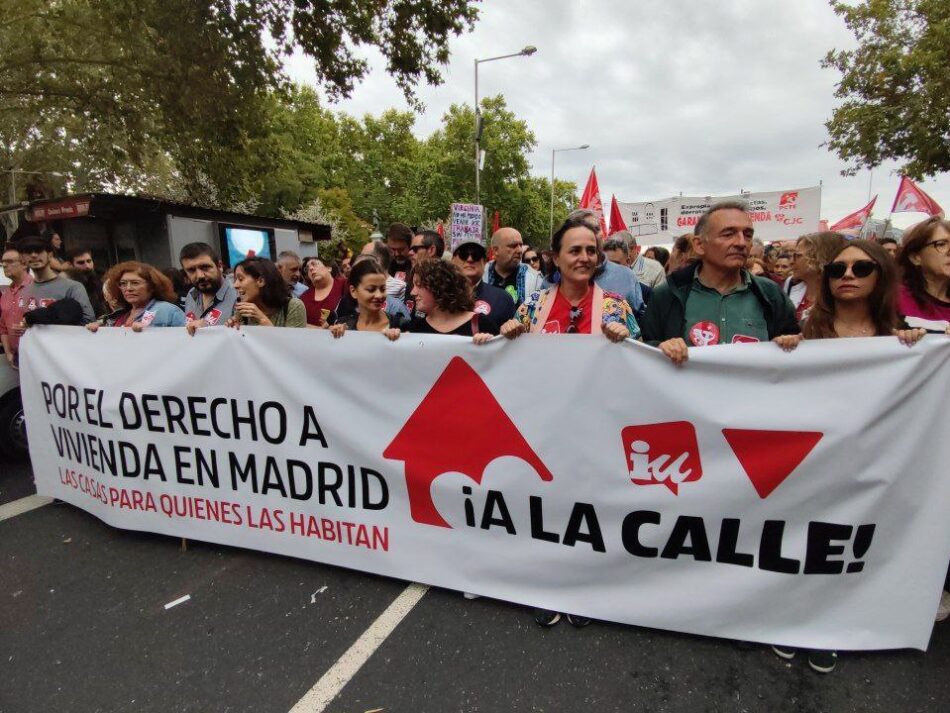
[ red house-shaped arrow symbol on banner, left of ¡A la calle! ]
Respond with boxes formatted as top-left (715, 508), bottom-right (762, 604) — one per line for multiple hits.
top-left (383, 357), bottom-right (553, 527)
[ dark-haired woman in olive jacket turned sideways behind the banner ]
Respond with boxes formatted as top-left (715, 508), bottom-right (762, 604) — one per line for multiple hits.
top-left (228, 257), bottom-right (307, 327)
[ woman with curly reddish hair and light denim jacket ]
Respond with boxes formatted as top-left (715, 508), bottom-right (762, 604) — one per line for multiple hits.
top-left (86, 261), bottom-right (185, 332)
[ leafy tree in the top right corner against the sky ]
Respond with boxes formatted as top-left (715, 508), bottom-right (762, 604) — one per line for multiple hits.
top-left (822, 0), bottom-right (950, 178)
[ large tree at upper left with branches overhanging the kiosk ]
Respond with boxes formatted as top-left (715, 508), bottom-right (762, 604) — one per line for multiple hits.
top-left (0, 0), bottom-right (477, 200)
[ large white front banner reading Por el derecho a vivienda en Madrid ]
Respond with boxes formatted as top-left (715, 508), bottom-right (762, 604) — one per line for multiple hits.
top-left (22, 327), bottom-right (950, 649)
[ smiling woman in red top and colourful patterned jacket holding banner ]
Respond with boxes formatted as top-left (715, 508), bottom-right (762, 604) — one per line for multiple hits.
top-left (501, 217), bottom-right (640, 342)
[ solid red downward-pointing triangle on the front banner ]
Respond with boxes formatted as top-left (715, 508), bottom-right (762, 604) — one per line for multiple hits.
top-left (722, 428), bottom-right (824, 500)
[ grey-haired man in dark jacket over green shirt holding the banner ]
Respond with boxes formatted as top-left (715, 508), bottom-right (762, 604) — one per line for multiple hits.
top-left (640, 201), bottom-right (801, 364)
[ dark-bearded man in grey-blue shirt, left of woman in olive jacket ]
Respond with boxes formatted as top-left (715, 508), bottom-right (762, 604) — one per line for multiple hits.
top-left (178, 243), bottom-right (238, 334)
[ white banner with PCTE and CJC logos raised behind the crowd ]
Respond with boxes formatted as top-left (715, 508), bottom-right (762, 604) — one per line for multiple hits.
top-left (617, 186), bottom-right (821, 245)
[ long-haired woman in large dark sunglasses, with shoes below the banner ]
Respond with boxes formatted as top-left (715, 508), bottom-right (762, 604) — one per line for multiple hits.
top-left (772, 240), bottom-right (926, 673)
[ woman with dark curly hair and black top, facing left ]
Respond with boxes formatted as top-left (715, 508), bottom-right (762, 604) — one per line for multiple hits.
top-left (408, 260), bottom-right (498, 344)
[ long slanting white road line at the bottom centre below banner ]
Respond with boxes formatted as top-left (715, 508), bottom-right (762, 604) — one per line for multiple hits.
top-left (290, 584), bottom-right (429, 713)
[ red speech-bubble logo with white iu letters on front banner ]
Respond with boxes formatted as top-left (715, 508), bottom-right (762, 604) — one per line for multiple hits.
top-left (620, 421), bottom-right (703, 495)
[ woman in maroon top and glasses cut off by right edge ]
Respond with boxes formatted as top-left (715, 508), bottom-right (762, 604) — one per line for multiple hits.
top-left (897, 217), bottom-right (950, 329)
